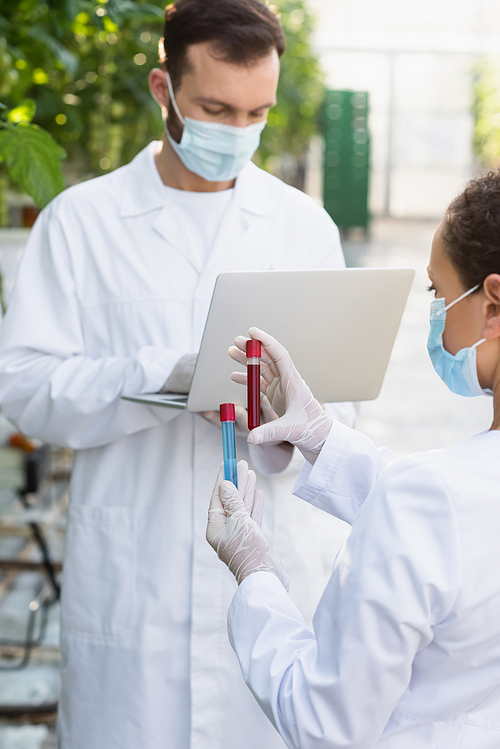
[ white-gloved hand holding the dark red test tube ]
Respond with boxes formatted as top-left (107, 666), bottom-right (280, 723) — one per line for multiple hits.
top-left (229, 328), bottom-right (333, 463)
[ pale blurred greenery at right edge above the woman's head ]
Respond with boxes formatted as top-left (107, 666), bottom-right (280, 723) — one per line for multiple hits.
top-left (473, 57), bottom-right (500, 168)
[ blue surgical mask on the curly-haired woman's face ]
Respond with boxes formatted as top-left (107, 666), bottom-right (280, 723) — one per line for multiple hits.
top-left (427, 284), bottom-right (493, 397)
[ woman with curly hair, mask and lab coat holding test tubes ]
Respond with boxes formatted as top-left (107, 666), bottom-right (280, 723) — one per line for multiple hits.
top-left (207, 173), bottom-right (500, 749)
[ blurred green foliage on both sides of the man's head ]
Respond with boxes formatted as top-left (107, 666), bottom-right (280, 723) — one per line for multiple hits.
top-left (0, 0), bottom-right (323, 182)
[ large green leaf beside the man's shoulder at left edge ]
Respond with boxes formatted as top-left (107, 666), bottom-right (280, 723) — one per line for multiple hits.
top-left (0, 122), bottom-right (66, 208)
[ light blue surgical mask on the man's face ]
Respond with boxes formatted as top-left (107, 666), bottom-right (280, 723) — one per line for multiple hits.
top-left (165, 73), bottom-right (266, 182)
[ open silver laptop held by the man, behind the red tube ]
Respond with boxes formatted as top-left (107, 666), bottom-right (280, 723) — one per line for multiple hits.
top-left (125, 268), bottom-right (415, 411)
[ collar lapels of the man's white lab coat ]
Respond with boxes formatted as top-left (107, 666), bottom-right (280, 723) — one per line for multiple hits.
top-left (120, 141), bottom-right (276, 218)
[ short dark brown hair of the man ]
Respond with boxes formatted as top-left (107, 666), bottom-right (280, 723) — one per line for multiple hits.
top-left (160, 0), bottom-right (285, 89)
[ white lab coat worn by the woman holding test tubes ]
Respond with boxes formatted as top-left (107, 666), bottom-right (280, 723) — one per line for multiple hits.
top-left (229, 425), bottom-right (500, 749)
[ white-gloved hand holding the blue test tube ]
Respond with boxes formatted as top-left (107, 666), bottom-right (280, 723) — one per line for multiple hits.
top-left (207, 460), bottom-right (288, 590)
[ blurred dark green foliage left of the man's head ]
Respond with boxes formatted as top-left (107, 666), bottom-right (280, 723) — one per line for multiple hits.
top-left (0, 0), bottom-right (163, 178)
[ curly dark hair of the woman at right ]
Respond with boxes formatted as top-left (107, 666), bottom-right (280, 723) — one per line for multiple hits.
top-left (442, 170), bottom-right (500, 289)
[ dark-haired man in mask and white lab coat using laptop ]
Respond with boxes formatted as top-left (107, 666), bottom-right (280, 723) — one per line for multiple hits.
top-left (0, 0), bottom-right (354, 749)
